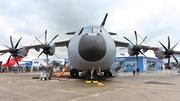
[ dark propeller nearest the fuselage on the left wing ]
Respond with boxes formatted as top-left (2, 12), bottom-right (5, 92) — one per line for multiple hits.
top-left (35, 30), bottom-right (58, 63)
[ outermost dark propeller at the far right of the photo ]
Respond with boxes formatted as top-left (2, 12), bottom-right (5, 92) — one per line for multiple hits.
top-left (158, 36), bottom-right (178, 66)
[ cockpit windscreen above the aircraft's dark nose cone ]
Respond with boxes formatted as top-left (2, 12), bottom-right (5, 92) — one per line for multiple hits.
top-left (82, 27), bottom-right (101, 33)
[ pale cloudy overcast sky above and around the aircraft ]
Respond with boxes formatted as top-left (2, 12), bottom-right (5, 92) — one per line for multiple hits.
top-left (0, 0), bottom-right (180, 60)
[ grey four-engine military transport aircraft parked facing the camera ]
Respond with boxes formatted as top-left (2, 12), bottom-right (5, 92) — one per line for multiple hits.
top-left (0, 14), bottom-right (180, 79)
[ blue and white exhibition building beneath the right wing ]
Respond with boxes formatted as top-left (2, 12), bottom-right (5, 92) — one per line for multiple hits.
top-left (114, 56), bottom-right (164, 72)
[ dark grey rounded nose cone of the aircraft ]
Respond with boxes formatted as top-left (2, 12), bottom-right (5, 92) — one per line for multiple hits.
top-left (78, 35), bottom-right (106, 62)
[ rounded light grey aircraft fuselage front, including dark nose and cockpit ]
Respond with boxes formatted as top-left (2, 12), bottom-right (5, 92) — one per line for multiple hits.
top-left (68, 26), bottom-right (116, 70)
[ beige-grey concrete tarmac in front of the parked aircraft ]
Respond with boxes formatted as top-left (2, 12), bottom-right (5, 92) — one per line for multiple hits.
top-left (0, 70), bottom-right (180, 101)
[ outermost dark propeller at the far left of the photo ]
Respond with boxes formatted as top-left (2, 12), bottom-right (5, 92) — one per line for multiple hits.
top-left (1, 36), bottom-right (22, 66)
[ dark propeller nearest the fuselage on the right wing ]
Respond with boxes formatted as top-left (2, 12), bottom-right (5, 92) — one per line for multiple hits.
top-left (124, 31), bottom-right (147, 62)
